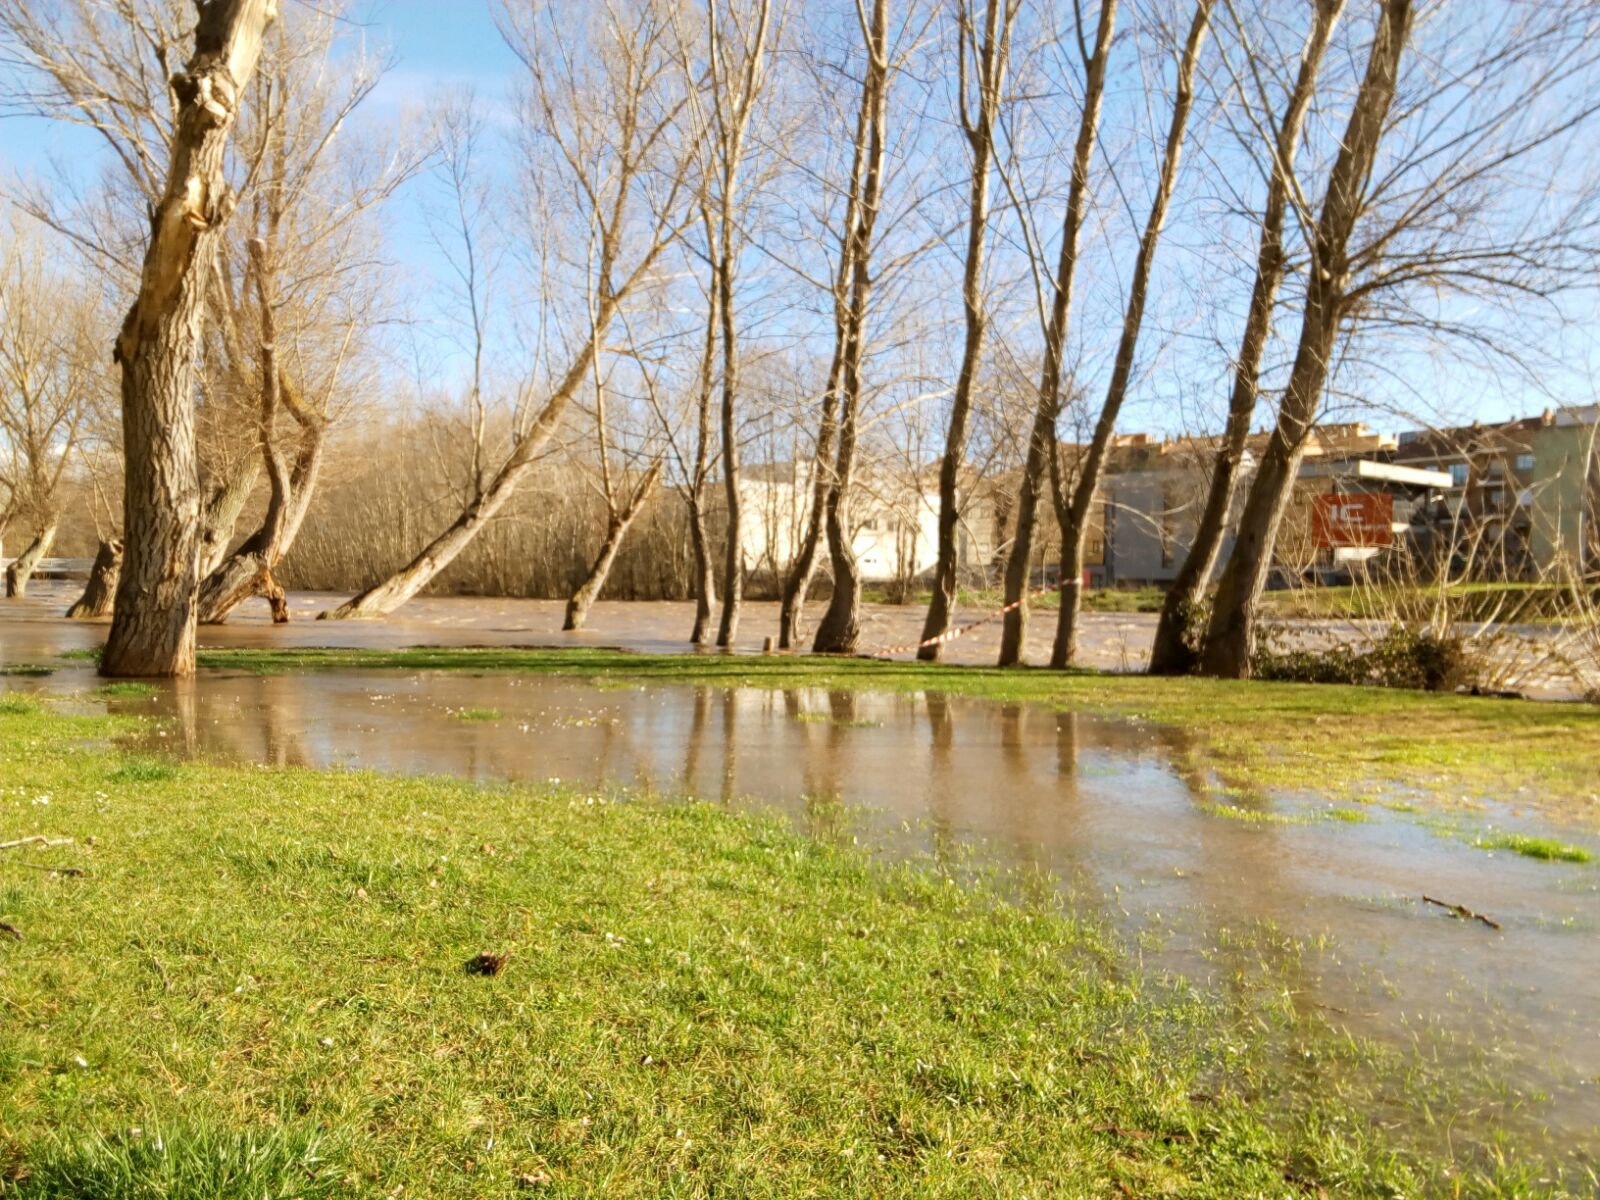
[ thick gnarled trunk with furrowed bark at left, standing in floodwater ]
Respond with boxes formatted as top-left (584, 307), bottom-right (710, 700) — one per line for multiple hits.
top-left (101, 0), bottom-right (277, 675)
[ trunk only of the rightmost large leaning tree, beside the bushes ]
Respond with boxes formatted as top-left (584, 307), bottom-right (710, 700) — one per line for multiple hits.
top-left (1200, 0), bottom-right (1411, 678)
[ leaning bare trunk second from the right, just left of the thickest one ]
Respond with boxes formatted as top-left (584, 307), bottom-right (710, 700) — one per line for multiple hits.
top-left (1150, 0), bottom-right (1344, 675)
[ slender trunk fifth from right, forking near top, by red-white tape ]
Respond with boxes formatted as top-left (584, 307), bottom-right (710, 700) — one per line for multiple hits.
top-left (917, 0), bottom-right (1016, 662)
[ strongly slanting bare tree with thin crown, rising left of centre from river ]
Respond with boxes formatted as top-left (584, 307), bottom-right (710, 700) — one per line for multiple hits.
top-left (323, 0), bottom-right (688, 619)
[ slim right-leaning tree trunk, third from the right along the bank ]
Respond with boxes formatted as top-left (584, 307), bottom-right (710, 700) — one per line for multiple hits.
top-left (1050, 0), bottom-right (1216, 670)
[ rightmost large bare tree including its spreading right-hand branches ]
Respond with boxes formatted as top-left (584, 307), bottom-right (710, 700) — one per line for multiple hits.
top-left (1200, 5), bottom-right (1600, 677)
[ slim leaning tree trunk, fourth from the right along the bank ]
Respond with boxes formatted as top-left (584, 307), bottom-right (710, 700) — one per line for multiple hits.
top-left (1000, 0), bottom-right (1117, 667)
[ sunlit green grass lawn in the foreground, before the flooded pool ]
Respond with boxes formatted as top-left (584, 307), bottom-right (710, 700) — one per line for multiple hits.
top-left (0, 699), bottom-right (1592, 1200)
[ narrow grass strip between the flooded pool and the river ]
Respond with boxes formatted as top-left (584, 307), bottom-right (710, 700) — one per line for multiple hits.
top-left (200, 648), bottom-right (1600, 829)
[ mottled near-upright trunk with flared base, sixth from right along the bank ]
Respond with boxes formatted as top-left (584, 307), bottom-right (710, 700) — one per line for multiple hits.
top-left (811, 0), bottom-right (890, 654)
